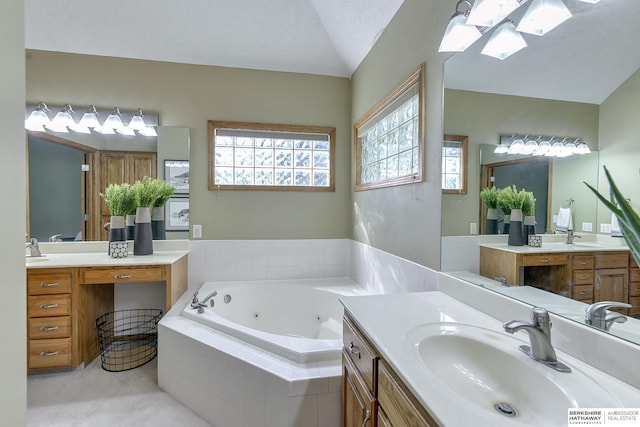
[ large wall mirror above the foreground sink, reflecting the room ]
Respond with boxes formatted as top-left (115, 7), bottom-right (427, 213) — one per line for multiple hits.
top-left (442, 0), bottom-right (640, 343)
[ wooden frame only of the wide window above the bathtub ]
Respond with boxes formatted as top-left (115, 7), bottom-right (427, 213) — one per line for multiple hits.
top-left (207, 120), bottom-right (336, 192)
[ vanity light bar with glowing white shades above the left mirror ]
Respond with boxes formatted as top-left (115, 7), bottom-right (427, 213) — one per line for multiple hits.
top-left (25, 102), bottom-right (159, 136)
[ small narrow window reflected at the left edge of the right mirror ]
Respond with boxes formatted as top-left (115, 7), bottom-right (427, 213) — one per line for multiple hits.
top-left (442, 135), bottom-right (468, 194)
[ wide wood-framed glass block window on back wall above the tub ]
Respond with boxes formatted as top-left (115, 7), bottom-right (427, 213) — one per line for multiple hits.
top-left (209, 121), bottom-right (335, 191)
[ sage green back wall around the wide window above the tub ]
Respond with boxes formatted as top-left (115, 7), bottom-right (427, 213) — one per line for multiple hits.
top-left (26, 51), bottom-right (351, 239)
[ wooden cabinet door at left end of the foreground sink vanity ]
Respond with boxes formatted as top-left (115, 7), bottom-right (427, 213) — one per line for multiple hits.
top-left (342, 355), bottom-right (377, 427)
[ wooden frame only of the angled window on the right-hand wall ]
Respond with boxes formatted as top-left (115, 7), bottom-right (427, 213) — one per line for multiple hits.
top-left (353, 63), bottom-right (426, 191)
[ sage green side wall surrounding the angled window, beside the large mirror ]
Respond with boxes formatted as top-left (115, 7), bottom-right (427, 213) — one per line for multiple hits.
top-left (351, 0), bottom-right (454, 269)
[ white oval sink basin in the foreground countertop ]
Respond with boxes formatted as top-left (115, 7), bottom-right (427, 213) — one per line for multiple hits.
top-left (405, 323), bottom-right (620, 426)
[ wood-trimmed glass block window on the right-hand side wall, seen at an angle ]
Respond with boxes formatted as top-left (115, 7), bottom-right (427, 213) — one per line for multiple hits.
top-left (354, 64), bottom-right (424, 191)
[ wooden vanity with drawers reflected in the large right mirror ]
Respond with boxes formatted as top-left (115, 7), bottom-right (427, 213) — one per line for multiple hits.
top-left (480, 244), bottom-right (640, 316)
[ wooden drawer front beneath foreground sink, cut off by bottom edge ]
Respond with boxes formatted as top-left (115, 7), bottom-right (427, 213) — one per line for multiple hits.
top-left (378, 362), bottom-right (437, 427)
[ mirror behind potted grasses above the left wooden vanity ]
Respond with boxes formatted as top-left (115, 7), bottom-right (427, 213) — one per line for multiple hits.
top-left (27, 126), bottom-right (189, 242)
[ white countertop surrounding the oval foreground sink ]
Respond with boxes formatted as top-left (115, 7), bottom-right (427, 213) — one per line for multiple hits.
top-left (341, 292), bottom-right (640, 427)
